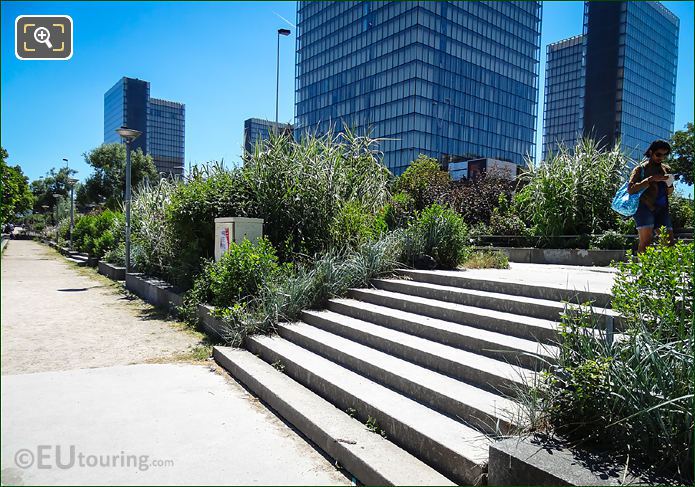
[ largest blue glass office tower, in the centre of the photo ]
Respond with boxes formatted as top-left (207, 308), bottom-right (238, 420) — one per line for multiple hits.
top-left (295, 1), bottom-right (541, 174)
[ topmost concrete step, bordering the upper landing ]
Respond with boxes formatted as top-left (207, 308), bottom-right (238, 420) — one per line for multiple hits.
top-left (398, 269), bottom-right (611, 308)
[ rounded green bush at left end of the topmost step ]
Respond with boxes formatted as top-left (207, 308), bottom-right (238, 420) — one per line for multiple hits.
top-left (405, 204), bottom-right (468, 269)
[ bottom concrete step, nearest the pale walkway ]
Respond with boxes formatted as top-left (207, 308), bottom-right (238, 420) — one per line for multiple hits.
top-left (213, 347), bottom-right (455, 485)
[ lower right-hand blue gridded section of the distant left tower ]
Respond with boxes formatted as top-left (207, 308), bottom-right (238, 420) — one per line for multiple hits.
top-left (147, 98), bottom-right (186, 174)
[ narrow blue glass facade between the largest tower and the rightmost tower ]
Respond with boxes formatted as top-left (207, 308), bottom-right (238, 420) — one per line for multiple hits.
top-left (543, 36), bottom-right (584, 159)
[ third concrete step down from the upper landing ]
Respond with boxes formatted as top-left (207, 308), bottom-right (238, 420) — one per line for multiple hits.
top-left (348, 289), bottom-right (560, 343)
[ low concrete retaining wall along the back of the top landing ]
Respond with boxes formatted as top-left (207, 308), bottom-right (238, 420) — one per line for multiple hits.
top-left (477, 247), bottom-right (627, 267)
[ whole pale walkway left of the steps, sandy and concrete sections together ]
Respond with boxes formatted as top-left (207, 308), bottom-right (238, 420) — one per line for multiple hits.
top-left (1, 240), bottom-right (350, 485)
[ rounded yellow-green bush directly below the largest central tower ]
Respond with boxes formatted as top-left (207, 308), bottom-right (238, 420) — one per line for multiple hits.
top-left (395, 154), bottom-right (451, 211)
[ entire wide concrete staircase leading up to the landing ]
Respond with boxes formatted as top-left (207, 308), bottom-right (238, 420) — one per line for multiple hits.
top-left (214, 270), bottom-right (620, 485)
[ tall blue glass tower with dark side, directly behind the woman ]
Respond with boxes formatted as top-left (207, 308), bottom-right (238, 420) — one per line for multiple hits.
top-left (544, 2), bottom-right (680, 158)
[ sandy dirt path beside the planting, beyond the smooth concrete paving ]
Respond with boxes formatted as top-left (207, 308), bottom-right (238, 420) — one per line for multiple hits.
top-left (1, 240), bottom-right (201, 375)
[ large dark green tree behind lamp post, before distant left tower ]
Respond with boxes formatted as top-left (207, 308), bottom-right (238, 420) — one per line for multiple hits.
top-left (77, 144), bottom-right (157, 209)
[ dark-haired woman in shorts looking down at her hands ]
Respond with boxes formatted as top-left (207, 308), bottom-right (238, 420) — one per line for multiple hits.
top-left (627, 140), bottom-right (674, 253)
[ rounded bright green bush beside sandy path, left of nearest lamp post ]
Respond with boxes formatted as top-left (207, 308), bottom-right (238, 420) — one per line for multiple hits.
top-left (72, 210), bottom-right (125, 259)
